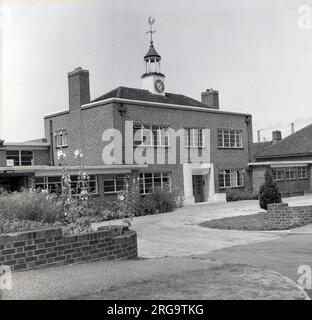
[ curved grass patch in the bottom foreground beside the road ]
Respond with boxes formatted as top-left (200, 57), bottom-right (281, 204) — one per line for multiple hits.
top-left (78, 264), bottom-right (305, 300)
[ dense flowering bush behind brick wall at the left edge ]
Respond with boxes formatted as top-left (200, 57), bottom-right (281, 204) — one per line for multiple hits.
top-left (0, 189), bottom-right (62, 223)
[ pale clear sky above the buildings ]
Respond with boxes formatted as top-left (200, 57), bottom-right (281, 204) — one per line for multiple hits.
top-left (0, 0), bottom-right (312, 141)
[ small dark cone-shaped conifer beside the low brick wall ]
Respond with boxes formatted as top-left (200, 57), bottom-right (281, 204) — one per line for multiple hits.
top-left (259, 168), bottom-right (282, 210)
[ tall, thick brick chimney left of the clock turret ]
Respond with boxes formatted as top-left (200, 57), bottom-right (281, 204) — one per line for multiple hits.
top-left (68, 67), bottom-right (90, 111)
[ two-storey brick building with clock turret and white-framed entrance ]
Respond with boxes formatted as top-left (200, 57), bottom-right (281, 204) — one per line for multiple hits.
top-left (0, 30), bottom-right (252, 204)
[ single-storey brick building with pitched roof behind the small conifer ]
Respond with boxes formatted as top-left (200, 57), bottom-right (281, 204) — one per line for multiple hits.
top-left (250, 125), bottom-right (312, 196)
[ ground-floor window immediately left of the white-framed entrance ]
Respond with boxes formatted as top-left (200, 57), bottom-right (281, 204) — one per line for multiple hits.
top-left (140, 172), bottom-right (171, 194)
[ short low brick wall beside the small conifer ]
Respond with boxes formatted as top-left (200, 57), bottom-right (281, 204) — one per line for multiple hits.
top-left (268, 203), bottom-right (312, 230)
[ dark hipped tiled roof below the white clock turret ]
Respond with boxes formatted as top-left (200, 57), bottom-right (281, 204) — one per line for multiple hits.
top-left (91, 87), bottom-right (208, 108)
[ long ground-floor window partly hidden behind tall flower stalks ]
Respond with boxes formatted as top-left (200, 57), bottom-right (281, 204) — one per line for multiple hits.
top-left (35, 175), bottom-right (98, 195)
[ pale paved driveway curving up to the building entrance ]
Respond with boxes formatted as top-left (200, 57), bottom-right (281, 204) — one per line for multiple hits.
top-left (132, 196), bottom-right (312, 258)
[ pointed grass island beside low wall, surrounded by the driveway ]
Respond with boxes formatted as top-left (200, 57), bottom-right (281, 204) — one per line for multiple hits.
top-left (199, 213), bottom-right (272, 231)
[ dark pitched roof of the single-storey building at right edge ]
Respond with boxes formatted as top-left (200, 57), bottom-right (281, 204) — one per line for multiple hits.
top-left (256, 124), bottom-right (312, 159)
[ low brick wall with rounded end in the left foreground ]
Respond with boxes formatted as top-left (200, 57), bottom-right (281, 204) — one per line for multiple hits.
top-left (0, 227), bottom-right (137, 271)
